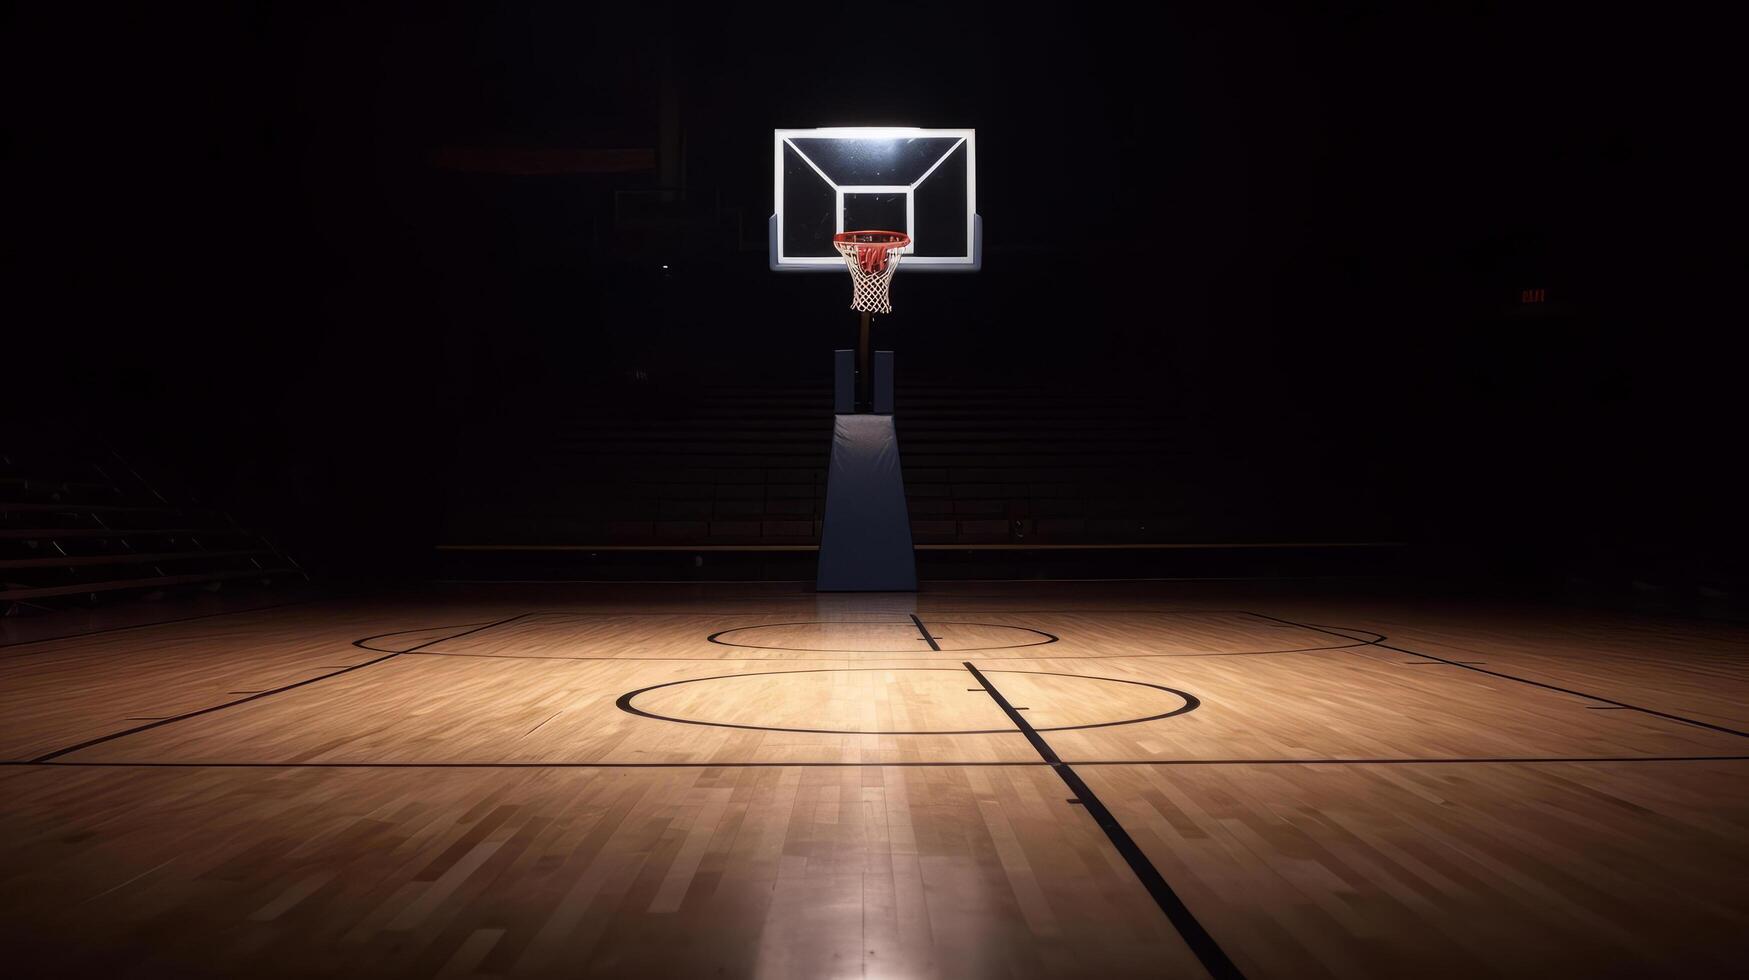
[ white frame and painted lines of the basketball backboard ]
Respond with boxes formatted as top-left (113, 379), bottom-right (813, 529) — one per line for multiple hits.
top-left (768, 126), bottom-right (983, 271)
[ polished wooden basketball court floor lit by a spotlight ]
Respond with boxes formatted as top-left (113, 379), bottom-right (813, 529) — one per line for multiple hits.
top-left (0, 583), bottom-right (1749, 978)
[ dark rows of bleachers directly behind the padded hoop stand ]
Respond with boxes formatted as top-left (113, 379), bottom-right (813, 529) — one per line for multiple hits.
top-left (433, 385), bottom-right (1375, 548)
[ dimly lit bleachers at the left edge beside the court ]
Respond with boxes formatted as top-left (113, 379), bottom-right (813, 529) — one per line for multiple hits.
top-left (0, 441), bottom-right (306, 614)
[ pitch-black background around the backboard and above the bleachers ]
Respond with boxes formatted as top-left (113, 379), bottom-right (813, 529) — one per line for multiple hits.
top-left (3, 2), bottom-right (1746, 598)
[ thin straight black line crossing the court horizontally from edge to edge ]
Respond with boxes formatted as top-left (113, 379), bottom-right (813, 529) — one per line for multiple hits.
top-left (0, 759), bottom-right (1749, 768)
